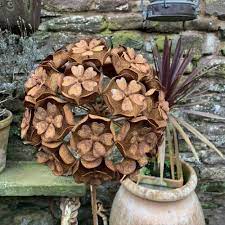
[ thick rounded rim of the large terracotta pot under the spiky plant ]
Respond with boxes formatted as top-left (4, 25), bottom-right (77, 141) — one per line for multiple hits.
top-left (122, 161), bottom-right (197, 202)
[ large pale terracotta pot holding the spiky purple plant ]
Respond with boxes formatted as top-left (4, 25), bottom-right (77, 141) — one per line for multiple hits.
top-left (109, 163), bottom-right (205, 225)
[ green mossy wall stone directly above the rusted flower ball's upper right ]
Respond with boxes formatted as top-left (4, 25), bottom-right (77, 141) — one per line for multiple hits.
top-left (112, 31), bottom-right (144, 50)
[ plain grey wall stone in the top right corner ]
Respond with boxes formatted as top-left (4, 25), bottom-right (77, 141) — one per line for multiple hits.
top-left (206, 0), bottom-right (225, 19)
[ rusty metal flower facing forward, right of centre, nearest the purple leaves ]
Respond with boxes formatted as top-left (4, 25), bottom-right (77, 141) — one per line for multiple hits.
top-left (106, 77), bottom-right (146, 116)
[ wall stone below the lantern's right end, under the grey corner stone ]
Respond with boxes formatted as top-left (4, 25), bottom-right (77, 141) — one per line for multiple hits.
top-left (184, 16), bottom-right (220, 32)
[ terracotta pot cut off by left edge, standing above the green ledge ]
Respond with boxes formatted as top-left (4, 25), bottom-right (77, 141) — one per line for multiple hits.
top-left (0, 110), bottom-right (12, 172)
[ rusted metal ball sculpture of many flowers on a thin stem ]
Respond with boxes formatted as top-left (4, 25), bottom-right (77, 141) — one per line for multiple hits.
top-left (21, 39), bottom-right (169, 225)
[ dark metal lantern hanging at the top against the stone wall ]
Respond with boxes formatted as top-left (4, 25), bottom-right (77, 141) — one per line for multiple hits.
top-left (141, 0), bottom-right (199, 21)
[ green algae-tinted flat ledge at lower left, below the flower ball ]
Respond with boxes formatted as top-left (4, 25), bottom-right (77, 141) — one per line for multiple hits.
top-left (0, 161), bottom-right (86, 197)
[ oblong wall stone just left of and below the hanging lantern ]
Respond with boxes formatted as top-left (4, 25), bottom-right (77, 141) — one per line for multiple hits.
top-left (107, 13), bottom-right (143, 31)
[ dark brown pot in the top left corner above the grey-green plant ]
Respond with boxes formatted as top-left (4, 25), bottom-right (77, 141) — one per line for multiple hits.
top-left (0, 0), bottom-right (41, 33)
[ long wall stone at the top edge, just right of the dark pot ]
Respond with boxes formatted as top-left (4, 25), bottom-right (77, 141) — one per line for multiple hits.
top-left (43, 0), bottom-right (94, 12)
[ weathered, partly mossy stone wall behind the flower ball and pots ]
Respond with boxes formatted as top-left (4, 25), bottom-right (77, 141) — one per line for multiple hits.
top-left (0, 0), bottom-right (225, 225)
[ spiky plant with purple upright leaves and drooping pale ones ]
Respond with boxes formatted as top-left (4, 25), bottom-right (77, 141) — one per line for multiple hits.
top-left (153, 37), bottom-right (225, 180)
